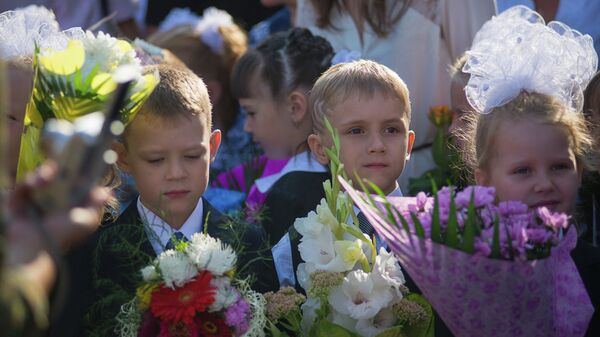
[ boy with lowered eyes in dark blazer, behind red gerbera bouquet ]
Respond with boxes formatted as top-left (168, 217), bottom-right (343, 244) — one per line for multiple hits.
top-left (87, 64), bottom-right (270, 336)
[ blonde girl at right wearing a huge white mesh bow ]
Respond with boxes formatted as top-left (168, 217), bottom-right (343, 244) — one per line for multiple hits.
top-left (463, 6), bottom-right (600, 336)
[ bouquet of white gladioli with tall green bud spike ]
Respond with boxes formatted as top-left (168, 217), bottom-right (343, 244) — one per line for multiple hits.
top-left (284, 121), bottom-right (433, 336)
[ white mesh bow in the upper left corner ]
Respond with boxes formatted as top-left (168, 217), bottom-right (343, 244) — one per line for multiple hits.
top-left (0, 5), bottom-right (60, 59)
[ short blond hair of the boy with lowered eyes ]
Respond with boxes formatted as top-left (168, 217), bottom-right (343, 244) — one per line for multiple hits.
top-left (126, 63), bottom-right (212, 132)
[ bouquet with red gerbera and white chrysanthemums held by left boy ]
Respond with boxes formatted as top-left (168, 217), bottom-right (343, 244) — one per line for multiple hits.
top-left (117, 233), bottom-right (266, 337)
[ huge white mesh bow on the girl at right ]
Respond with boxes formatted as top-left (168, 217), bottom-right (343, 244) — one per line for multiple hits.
top-left (463, 6), bottom-right (598, 113)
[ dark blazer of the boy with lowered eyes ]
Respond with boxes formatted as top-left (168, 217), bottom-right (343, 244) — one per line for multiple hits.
top-left (85, 199), bottom-right (278, 337)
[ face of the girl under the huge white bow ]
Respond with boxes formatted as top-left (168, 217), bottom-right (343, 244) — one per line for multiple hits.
top-left (475, 120), bottom-right (581, 213)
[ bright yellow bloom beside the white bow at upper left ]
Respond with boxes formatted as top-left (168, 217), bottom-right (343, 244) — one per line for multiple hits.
top-left (39, 39), bottom-right (85, 76)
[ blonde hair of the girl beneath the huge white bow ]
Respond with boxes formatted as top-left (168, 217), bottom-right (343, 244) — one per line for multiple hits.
top-left (463, 90), bottom-right (593, 171)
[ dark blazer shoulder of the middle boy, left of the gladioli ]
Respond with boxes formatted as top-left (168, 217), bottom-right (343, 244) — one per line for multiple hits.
top-left (262, 171), bottom-right (331, 246)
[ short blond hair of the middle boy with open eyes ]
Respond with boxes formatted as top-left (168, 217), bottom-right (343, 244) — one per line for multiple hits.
top-left (309, 60), bottom-right (411, 134)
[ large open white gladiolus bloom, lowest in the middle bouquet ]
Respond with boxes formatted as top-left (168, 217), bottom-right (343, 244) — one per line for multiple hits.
top-left (328, 270), bottom-right (394, 320)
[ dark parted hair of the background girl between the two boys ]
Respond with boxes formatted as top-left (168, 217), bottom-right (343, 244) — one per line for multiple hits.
top-left (231, 28), bottom-right (333, 99)
